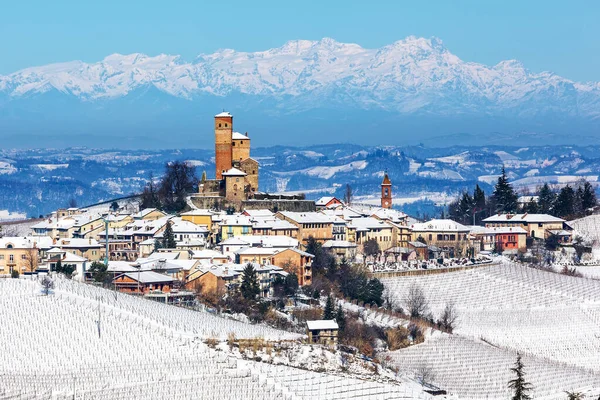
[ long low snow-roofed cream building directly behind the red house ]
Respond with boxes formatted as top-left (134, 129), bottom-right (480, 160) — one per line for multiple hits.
top-left (482, 213), bottom-right (568, 239)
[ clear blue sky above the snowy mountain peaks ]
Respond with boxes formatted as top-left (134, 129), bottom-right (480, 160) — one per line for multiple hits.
top-left (0, 0), bottom-right (600, 81)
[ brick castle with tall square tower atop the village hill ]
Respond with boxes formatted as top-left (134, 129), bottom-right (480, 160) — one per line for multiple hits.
top-left (199, 112), bottom-right (258, 204)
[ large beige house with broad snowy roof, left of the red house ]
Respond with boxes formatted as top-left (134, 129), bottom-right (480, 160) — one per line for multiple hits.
top-left (410, 219), bottom-right (476, 257)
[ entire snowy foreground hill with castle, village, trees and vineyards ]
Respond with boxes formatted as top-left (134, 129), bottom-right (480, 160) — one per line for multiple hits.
top-left (0, 112), bottom-right (600, 399)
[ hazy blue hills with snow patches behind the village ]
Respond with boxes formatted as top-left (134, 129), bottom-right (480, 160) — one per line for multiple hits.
top-left (0, 144), bottom-right (600, 216)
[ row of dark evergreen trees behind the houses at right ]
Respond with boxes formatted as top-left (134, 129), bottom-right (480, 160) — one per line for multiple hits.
top-left (448, 168), bottom-right (598, 225)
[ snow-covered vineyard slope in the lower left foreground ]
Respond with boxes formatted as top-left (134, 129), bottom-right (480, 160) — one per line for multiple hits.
top-left (0, 279), bottom-right (430, 399)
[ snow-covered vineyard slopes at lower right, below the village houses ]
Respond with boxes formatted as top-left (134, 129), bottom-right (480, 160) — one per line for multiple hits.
top-left (383, 262), bottom-right (600, 399)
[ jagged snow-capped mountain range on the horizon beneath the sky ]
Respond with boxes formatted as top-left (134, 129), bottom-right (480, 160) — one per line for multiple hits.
top-left (0, 37), bottom-right (600, 147)
